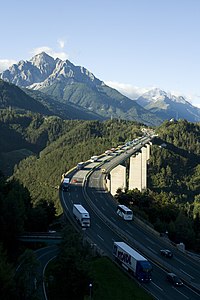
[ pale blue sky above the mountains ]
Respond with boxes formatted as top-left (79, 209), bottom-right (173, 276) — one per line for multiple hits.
top-left (0, 0), bottom-right (200, 107)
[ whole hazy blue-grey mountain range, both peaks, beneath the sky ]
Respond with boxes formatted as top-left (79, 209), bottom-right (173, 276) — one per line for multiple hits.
top-left (0, 52), bottom-right (200, 125)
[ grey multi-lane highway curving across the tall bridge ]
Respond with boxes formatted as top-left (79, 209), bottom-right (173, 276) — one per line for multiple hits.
top-left (60, 140), bottom-right (200, 300)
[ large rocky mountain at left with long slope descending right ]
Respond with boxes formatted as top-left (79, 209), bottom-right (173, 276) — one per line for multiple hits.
top-left (1, 52), bottom-right (161, 125)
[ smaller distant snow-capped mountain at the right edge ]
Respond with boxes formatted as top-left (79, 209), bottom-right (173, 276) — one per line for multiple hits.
top-left (137, 88), bottom-right (200, 122)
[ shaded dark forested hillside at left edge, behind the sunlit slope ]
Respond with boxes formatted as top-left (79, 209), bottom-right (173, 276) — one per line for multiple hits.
top-left (0, 109), bottom-right (74, 176)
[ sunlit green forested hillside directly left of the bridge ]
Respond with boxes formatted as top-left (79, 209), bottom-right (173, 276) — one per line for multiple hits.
top-left (11, 119), bottom-right (144, 212)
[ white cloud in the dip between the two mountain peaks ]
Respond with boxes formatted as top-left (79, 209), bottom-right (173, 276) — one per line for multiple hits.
top-left (105, 81), bottom-right (153, 100)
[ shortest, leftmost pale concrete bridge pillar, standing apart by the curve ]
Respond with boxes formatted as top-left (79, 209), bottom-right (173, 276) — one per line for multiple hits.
top-left (110, 165), bottom-right (126, 196)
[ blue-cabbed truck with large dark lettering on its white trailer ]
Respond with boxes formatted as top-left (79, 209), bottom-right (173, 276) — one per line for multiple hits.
top-left (113, 242), bottom-right (152, 282)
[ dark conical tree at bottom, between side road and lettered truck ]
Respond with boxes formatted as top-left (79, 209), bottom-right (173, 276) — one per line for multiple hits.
top-left (48, 227), bottom-right (90, 300)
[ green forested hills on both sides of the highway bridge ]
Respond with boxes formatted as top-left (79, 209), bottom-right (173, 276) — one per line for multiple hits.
top-left (0, 111), bottom-right (200, 248)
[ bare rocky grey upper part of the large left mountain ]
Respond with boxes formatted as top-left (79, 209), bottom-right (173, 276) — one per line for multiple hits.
top-left (0, 52), bottom-right (103, 89)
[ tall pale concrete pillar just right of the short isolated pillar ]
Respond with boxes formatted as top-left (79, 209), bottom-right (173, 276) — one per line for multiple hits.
top-left (129, 152), bottom-right (142, 191)
